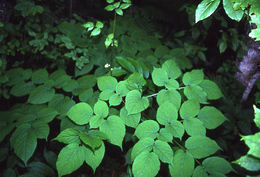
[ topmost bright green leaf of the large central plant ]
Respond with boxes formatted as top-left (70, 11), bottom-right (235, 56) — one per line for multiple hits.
top-left (162, 60), bottom-right (182, 79)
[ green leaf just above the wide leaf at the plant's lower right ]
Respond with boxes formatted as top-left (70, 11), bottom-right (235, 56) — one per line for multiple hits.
top-left (183, 118), bottom-right (206, 136)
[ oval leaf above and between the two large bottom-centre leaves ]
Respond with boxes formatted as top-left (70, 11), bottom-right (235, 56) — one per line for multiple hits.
top-left (153, 140), bottom-right (173, 164)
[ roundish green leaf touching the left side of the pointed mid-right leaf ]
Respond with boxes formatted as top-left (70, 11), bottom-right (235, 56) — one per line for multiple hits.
top-left (180, 100), bottom-right (200, 119)
